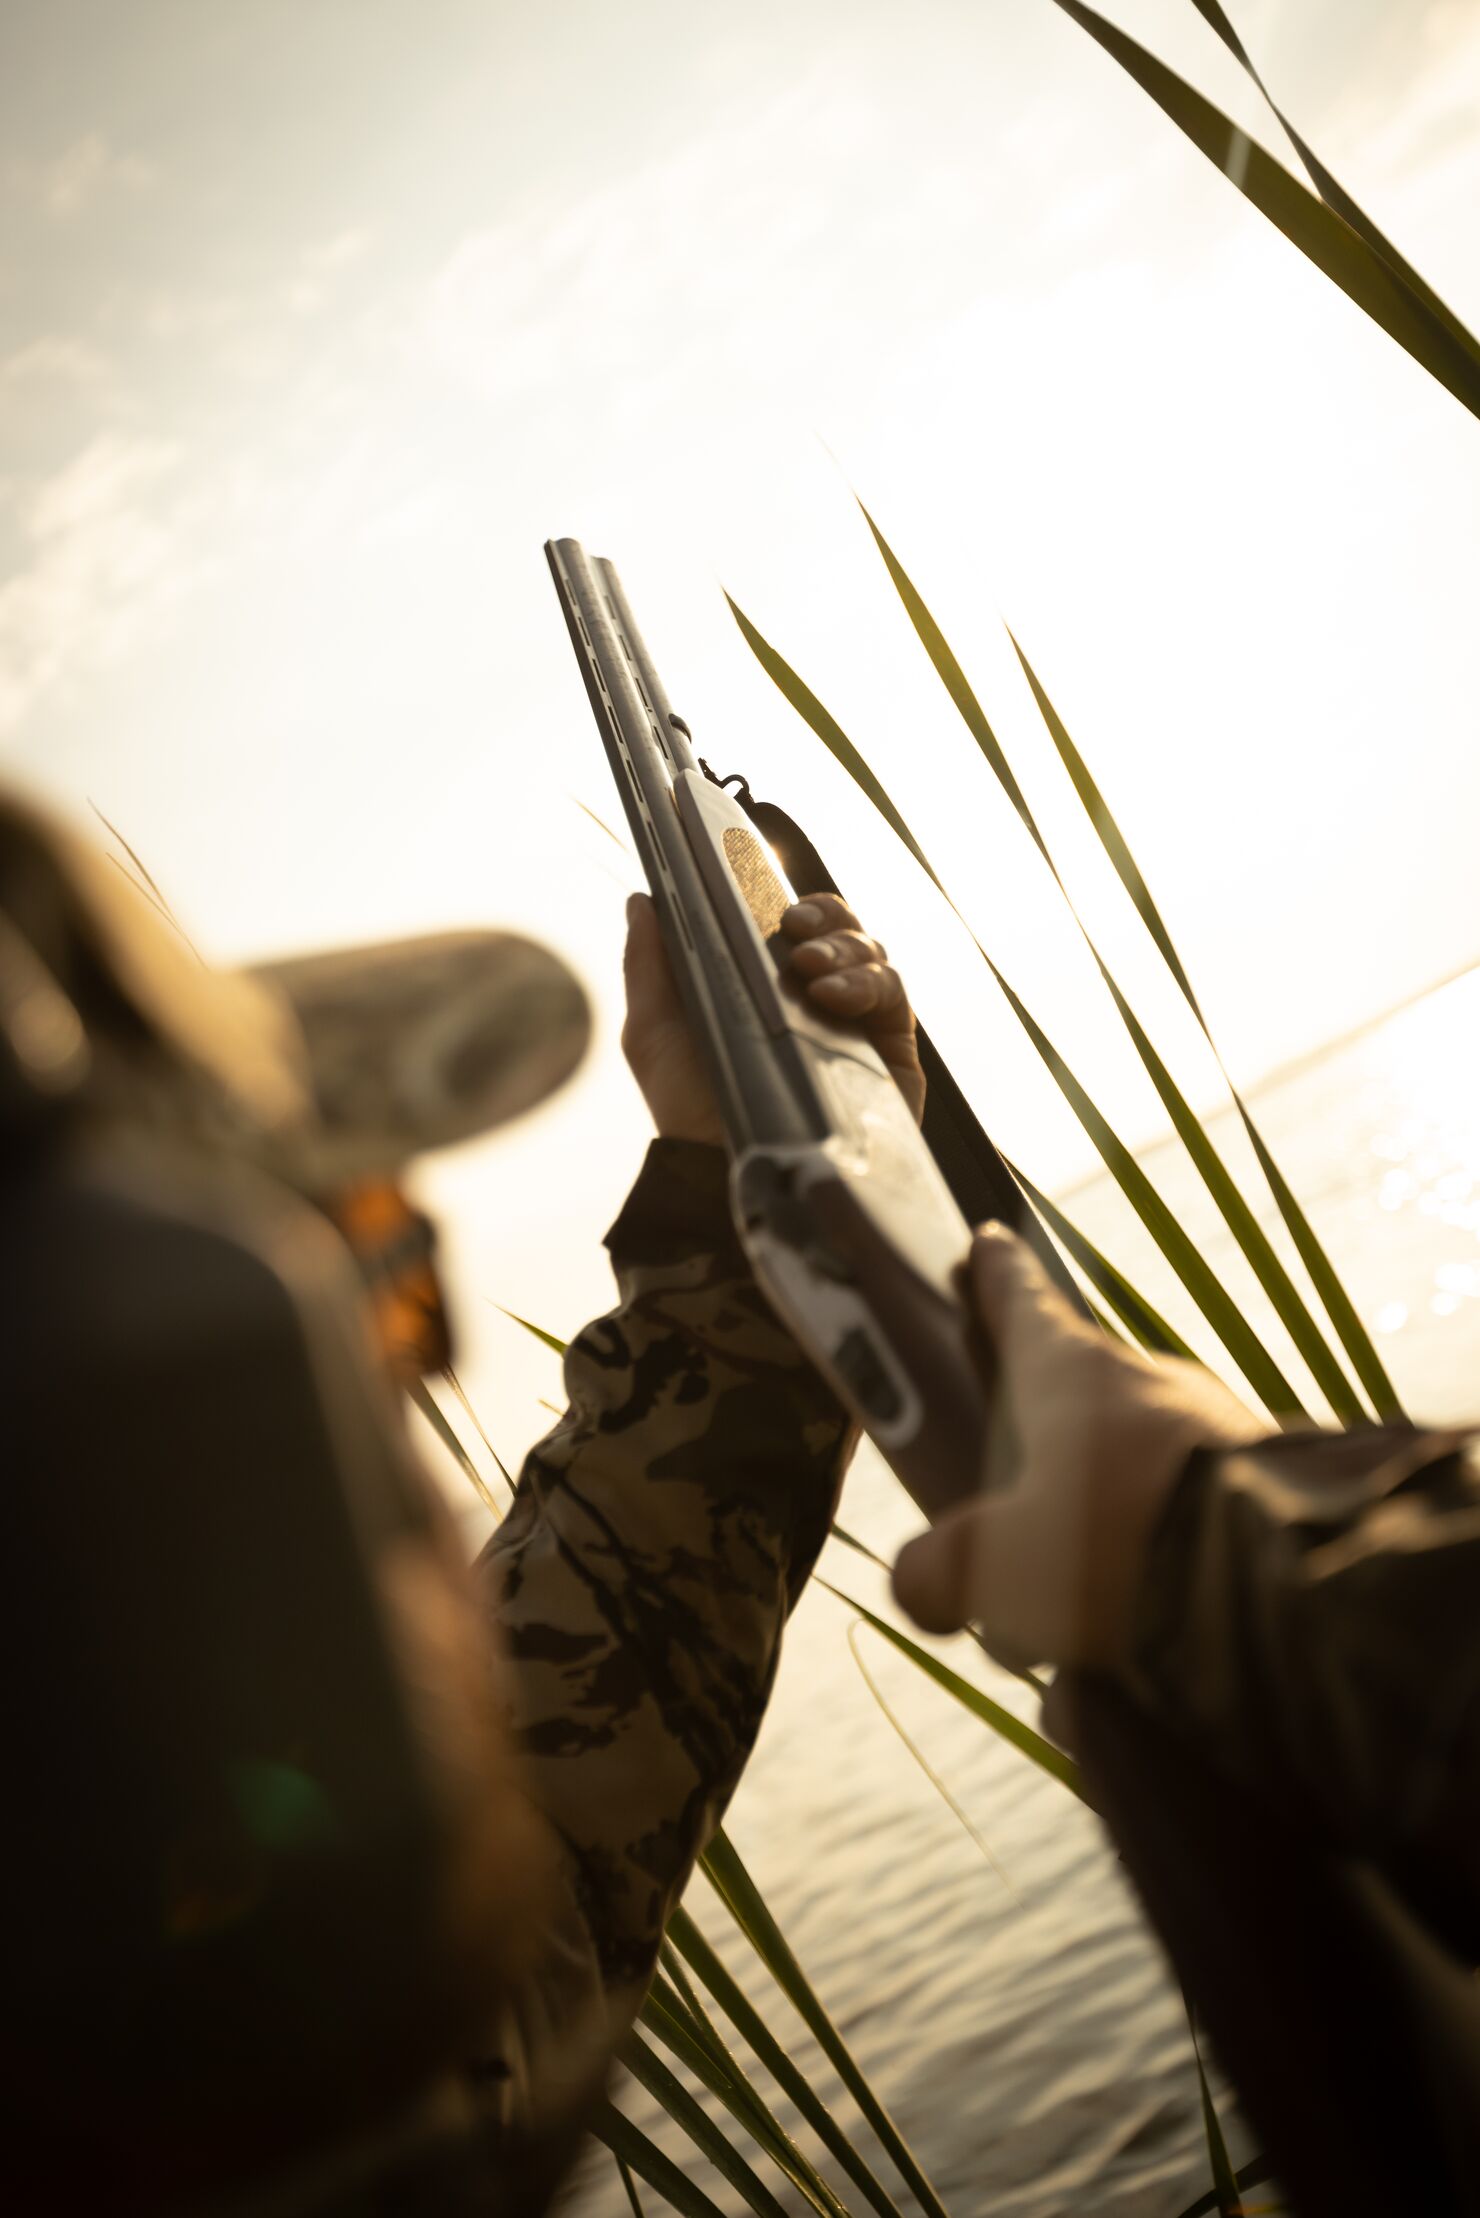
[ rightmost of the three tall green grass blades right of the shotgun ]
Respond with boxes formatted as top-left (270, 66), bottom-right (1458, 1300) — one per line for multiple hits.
top-left (1007, 632), bottom-right (1402, 1424)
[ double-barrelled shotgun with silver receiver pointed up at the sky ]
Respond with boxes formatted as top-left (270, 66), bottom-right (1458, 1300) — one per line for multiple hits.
top-left (546, 539), bottom-right (994, 1517)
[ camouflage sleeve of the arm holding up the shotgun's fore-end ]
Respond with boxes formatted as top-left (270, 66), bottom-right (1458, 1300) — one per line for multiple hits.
top-left (468, 1140), bottom-right (850, 2125)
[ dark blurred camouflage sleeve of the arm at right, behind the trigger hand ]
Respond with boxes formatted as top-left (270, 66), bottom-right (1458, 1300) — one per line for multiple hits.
top-left (1087, 1426), bottom-right (1480, 2218)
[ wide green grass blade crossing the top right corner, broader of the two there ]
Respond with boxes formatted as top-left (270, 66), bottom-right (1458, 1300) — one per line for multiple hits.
top-left (1054, 0), bottom-right (1480, 415)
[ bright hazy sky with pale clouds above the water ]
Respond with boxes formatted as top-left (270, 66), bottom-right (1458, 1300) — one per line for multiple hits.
top-left (0, 0), bottom-right (1480, 1490)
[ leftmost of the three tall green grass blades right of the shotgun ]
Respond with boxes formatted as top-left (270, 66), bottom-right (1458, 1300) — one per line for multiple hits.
top-left (730, 601), bottom-right (1305, 1420)
